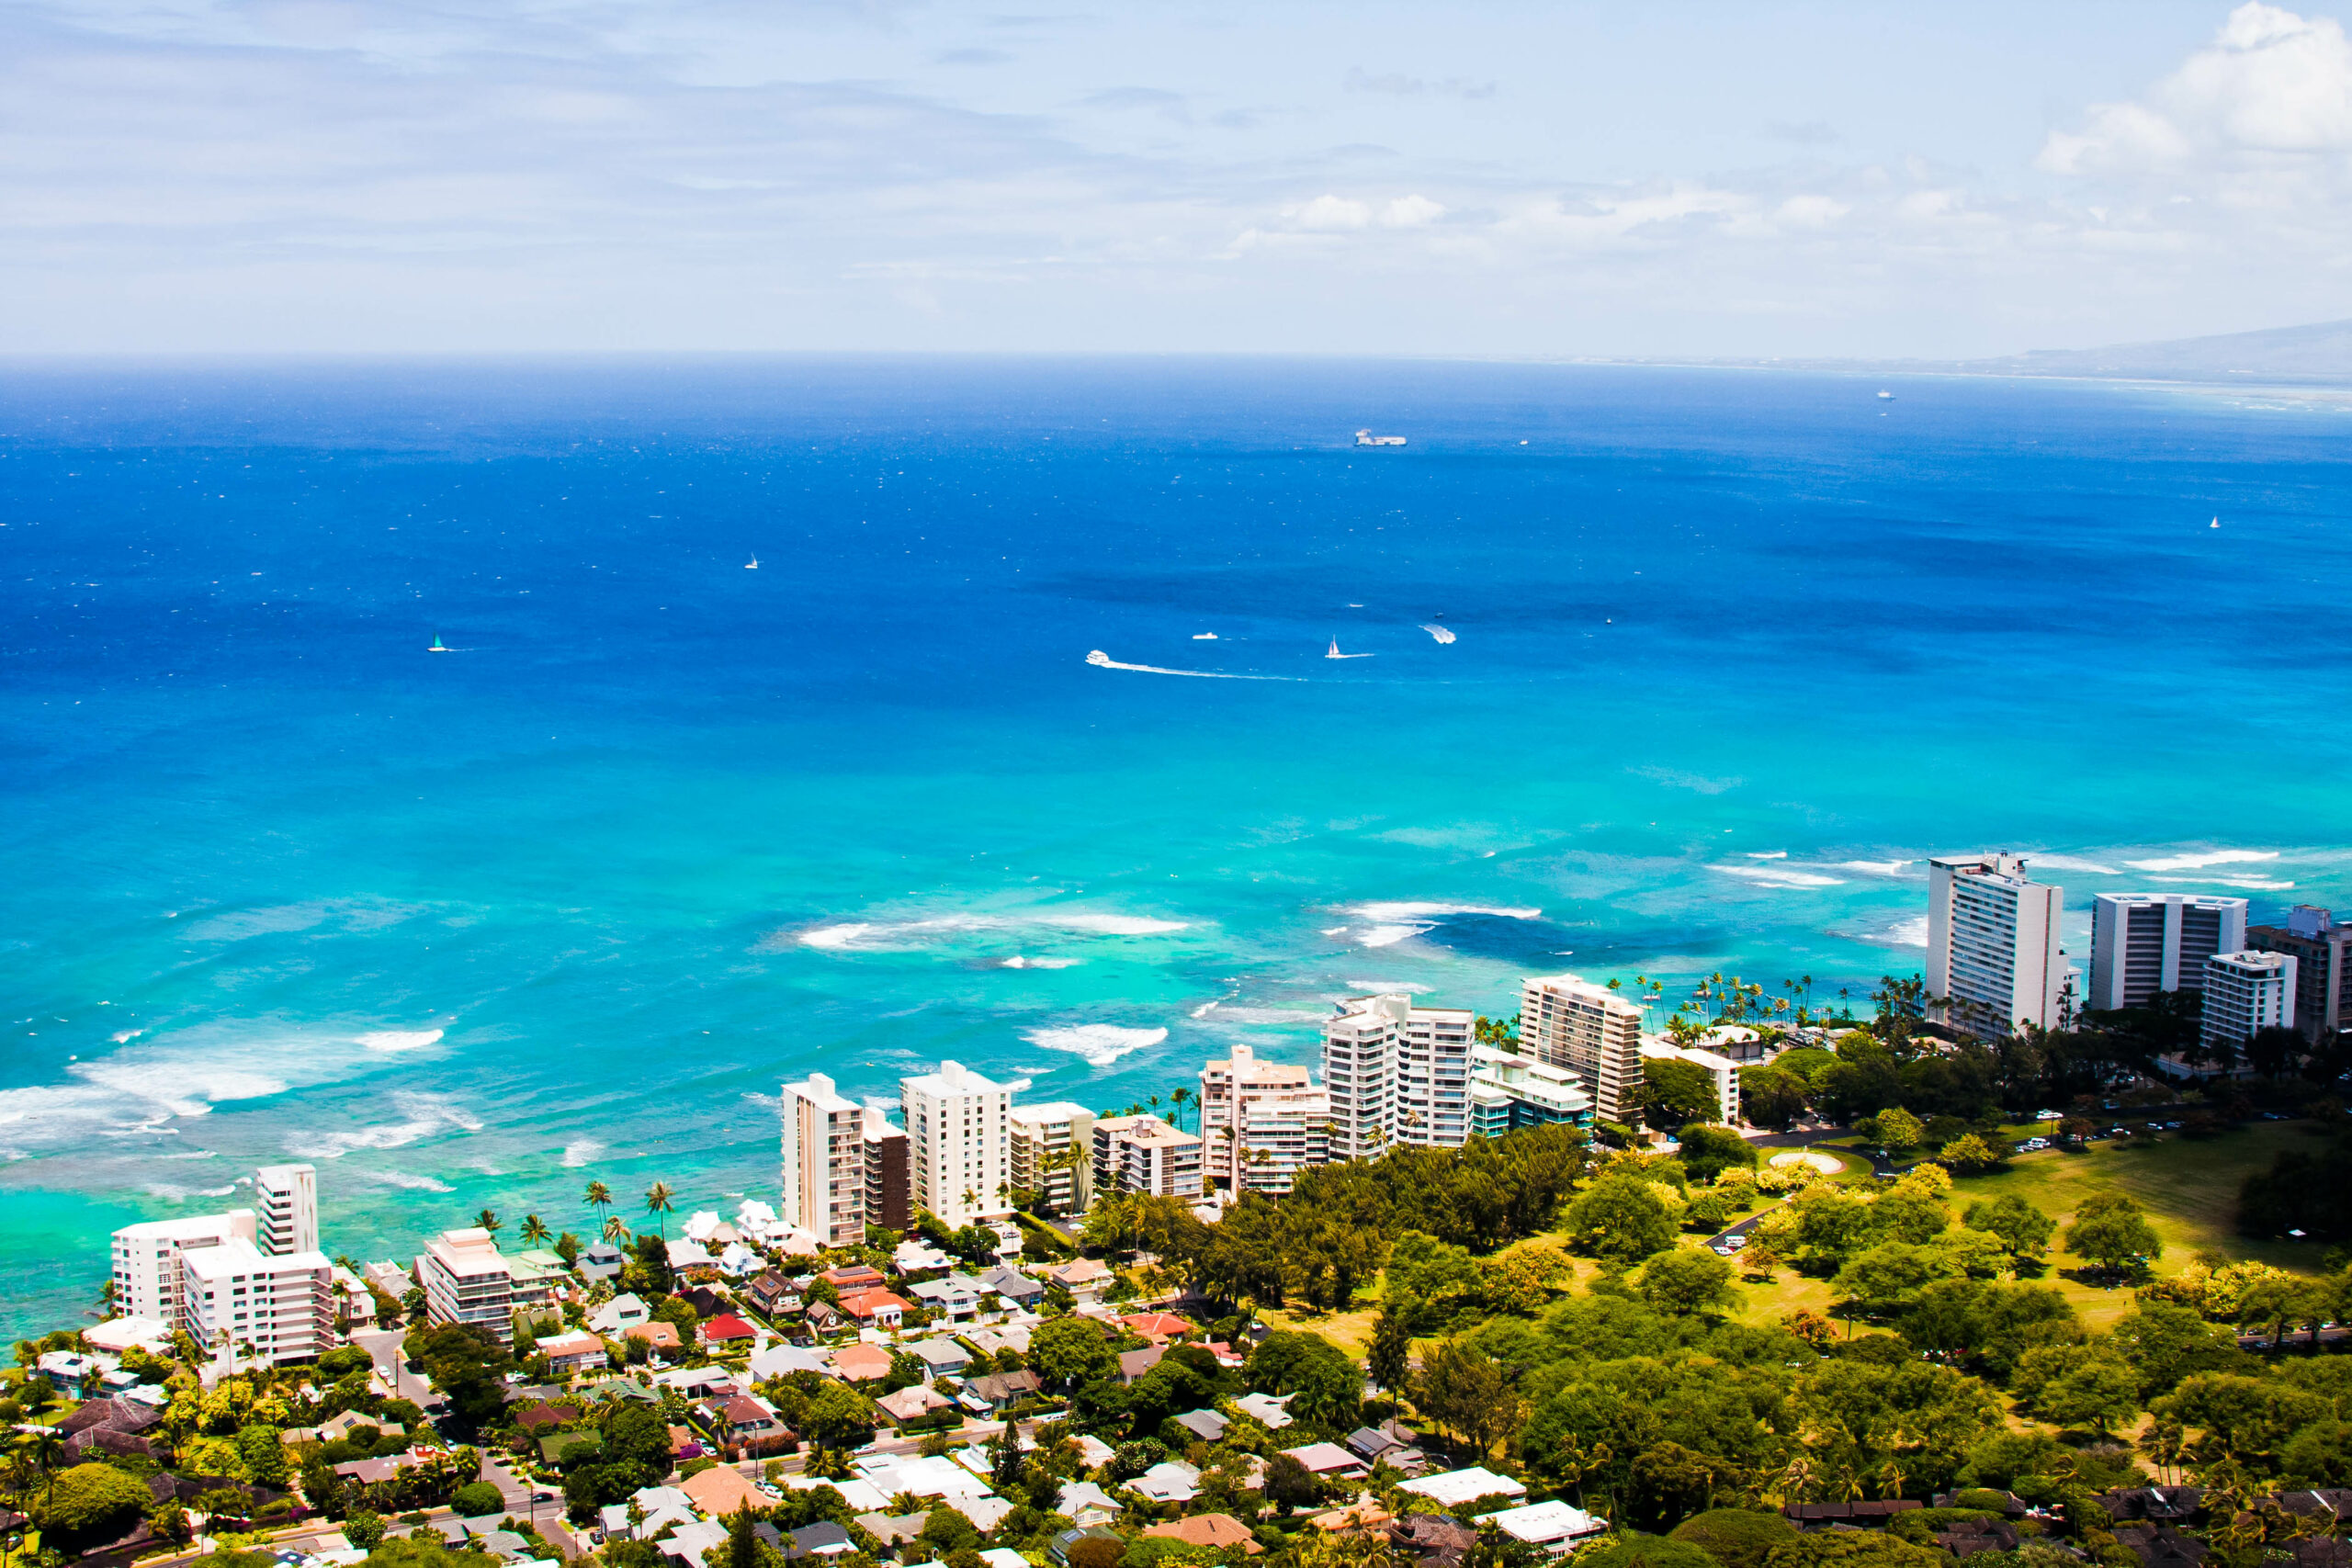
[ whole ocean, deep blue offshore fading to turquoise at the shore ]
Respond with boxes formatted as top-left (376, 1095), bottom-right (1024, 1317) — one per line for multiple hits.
top-left (0, 360), bottom-right (2352, 1331)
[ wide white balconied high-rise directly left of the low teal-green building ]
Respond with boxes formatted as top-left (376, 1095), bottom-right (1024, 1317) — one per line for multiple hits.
top-left (1324, 992), bottom-right (1473, 1159)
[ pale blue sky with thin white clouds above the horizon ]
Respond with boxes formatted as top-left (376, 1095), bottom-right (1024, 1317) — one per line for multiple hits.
top-left (0, 0), bottom-right (2352, 357)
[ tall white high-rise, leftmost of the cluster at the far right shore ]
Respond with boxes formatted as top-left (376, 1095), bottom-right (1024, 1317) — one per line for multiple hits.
top-left (1927, 856), bottom-right (2070, 1037)
